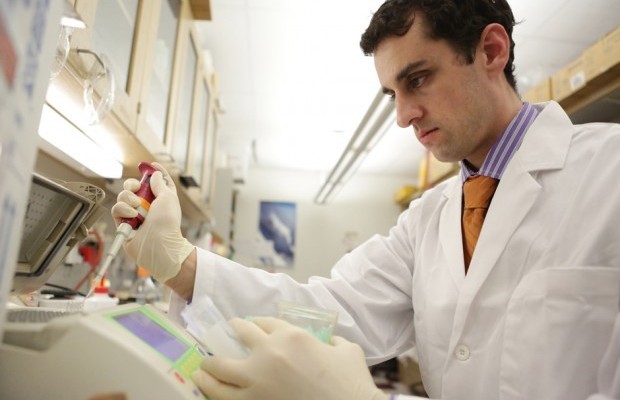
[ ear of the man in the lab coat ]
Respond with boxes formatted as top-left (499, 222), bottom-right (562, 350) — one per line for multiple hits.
top-left (478, 23), bottom-right (510, 76)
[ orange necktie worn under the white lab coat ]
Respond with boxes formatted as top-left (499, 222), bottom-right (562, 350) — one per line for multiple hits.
top-left (462, 175), bottom-right (499, 273)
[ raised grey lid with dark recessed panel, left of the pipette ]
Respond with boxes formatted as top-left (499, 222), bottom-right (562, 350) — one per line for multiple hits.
top-left (11, 174), bottom-right (105, 294)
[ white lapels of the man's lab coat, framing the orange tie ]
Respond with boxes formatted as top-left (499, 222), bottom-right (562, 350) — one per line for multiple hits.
top-left (439, 102), bottom-right (574, 310)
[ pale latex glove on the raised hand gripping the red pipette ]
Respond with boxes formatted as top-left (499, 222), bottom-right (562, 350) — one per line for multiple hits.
top-left (112, 163), bottom-right (194, 282)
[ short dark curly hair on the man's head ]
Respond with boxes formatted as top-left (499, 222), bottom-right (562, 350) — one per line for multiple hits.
top-left (360, 0), bottom-right (517, 91)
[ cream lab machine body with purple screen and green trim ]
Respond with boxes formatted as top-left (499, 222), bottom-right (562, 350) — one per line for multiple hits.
top-left (0, 303), bottom-right (206, 400)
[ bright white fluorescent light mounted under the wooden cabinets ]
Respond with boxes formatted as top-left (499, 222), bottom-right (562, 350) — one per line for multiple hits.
top-left (39, 104), bottom-right (123, 179)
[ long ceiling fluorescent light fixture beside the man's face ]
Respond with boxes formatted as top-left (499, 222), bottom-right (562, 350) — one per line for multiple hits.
top-left (314, 90), bottom-right (395, 204)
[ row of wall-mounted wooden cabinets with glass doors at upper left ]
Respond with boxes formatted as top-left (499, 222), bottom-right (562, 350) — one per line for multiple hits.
top-left (41, 0), bottom-right (217, 222)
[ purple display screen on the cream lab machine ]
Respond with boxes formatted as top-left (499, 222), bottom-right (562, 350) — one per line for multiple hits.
top-left (113, 311), bottom-right (188, 362)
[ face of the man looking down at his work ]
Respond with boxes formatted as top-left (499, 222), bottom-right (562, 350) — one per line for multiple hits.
top-left (374, 14), bottom-right (497, 167)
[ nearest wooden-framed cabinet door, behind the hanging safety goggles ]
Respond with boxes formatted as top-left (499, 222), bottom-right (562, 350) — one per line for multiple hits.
top-left (71, 0), bottom-right (153, 132)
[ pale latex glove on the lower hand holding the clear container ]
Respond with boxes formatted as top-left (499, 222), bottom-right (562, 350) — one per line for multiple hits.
top-left (193, 318), bottom-right (389, 400)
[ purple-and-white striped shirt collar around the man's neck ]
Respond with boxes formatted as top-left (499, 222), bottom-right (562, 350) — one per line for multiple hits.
top-left (461, 103), bottom-right (538, 182)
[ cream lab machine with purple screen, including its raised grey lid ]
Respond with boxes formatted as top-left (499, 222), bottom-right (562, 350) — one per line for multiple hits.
top-left (0, 175), bottom-right (206, 400)
